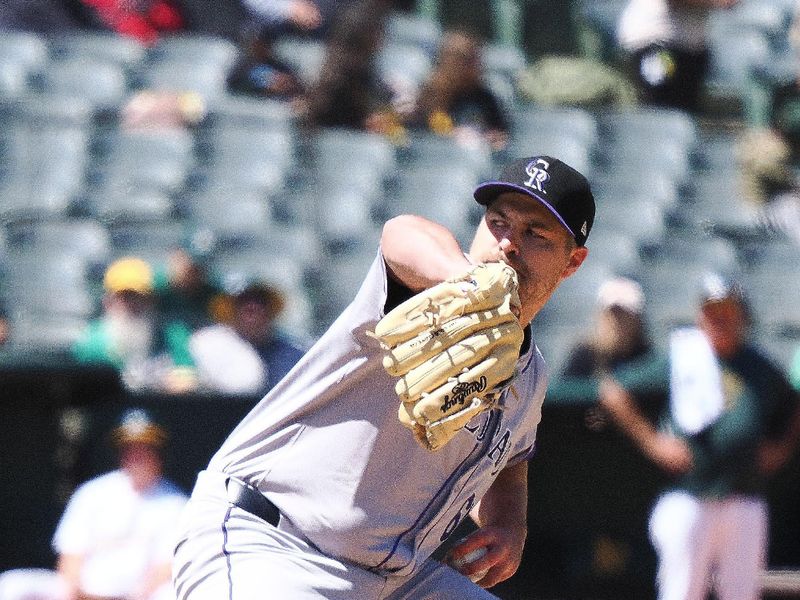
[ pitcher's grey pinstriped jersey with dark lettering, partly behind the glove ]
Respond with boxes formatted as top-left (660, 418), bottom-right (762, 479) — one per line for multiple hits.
top-left (203, 254), bottom-right (547, 576)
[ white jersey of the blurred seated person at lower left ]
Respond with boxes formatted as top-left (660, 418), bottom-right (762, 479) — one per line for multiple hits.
top-left (53, 470), bottom-right (187, 598)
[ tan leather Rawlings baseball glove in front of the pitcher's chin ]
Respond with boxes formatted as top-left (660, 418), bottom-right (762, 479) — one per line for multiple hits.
top-left (373, 263), bottom-right (523, 450)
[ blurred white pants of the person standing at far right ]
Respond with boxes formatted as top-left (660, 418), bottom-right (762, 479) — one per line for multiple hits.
top-left (650, 492), bottom-right (768, 600)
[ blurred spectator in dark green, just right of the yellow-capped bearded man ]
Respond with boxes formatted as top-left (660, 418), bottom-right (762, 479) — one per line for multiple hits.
top-left (153, 243), bottom-right (224, 331)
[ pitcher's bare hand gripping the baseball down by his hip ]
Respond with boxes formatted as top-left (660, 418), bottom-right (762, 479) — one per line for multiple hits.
top-left (447, 525), bottom-right (527, 588)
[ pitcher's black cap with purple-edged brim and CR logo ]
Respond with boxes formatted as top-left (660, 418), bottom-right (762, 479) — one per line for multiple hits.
top-left (473, 155), bottom-right (594, 246)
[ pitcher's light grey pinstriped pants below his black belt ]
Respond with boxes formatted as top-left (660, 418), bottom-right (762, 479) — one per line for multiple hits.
top-left (173, 472), bottom-right (497, 600)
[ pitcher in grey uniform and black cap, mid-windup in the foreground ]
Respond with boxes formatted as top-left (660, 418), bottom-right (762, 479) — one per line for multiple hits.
top-left (173, 156), bottom-right (595, 600)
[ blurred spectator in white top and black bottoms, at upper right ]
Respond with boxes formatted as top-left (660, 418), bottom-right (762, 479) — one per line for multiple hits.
top-left (617, 0), bottom-right (738, 111)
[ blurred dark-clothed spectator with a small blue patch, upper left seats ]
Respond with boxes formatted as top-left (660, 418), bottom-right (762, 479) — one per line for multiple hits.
top-left (228, 22), bottom-right (302, 100)
